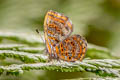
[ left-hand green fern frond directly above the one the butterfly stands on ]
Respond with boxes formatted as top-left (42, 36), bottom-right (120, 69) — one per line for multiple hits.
top-left (0, 50), bottom-right (48, 63)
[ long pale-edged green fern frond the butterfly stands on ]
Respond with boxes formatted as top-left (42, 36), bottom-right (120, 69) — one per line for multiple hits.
top-left (0, 59), bottom-right (120, 77)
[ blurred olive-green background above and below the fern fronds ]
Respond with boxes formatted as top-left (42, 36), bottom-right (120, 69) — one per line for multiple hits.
top-left (0, 0), bottom-right (120, 80)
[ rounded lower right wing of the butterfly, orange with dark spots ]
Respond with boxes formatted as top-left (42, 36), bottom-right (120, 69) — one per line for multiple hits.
top-left (55, 35), bottom-right (87, 62)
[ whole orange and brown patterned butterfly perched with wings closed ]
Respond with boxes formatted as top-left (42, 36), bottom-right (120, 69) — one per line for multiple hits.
top-left (44, 10), bottom-right (87, 62)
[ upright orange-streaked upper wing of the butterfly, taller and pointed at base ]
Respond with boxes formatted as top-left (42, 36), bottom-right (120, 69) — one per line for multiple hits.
top-left (44, 10), bottom-right (73, 54)
